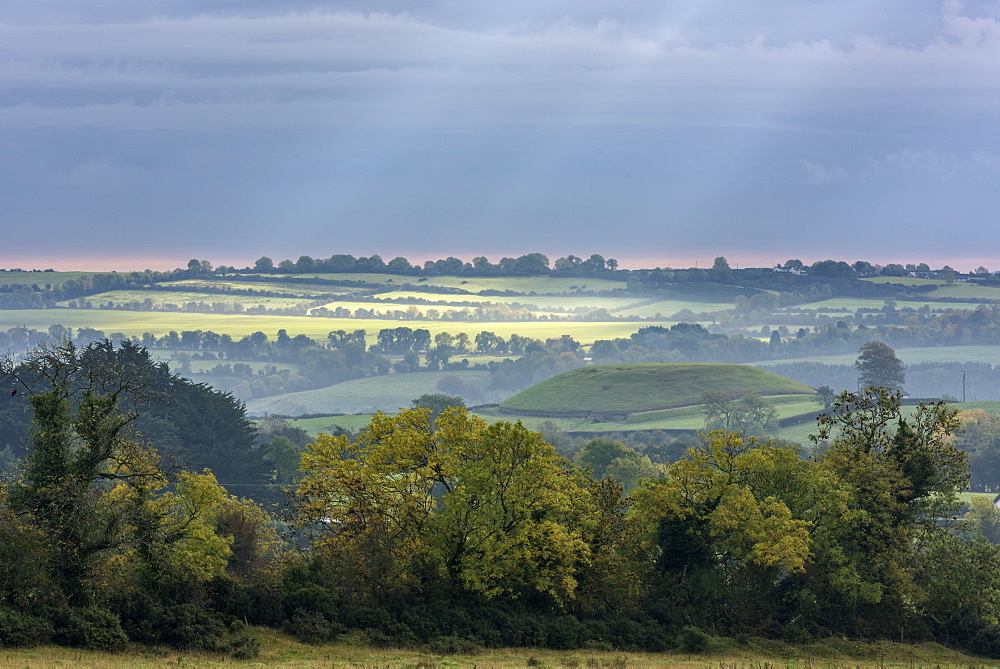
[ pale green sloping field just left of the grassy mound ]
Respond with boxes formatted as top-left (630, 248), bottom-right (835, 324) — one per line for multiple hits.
top-left (247, 371), bottom-right (489, 416)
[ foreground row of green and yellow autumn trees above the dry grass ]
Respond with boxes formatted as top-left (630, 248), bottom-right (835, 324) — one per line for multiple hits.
top-left (0, 343), bottom-right (1000, 658)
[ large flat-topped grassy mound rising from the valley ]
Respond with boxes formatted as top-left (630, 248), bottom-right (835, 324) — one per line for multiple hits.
top-left (501, 363), bottom-right (812, 411)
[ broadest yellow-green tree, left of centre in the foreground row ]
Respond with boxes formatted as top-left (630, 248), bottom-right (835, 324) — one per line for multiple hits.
top-left (296, 408), bottom-right (596, 601)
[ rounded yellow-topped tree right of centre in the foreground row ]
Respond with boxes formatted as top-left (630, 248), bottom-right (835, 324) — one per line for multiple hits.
top-left (629, 431), bottom-right (826, 626)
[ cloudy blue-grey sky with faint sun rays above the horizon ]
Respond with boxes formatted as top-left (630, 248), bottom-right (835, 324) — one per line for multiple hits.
top-left (0, 0), bottom-right (1000, 271)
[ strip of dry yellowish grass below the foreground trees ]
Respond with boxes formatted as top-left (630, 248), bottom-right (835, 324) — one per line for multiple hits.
top-left (0, 629), bottom-right (997, 669)
